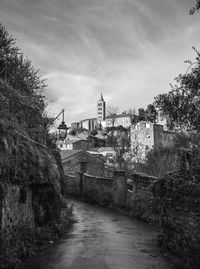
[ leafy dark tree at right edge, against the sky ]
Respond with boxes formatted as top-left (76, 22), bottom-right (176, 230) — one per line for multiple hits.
top-left (154, 48), bottom-right (200, 132)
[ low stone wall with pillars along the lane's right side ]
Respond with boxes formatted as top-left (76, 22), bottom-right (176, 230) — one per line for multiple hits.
top-left (65, 171), bottom-right (157, 209)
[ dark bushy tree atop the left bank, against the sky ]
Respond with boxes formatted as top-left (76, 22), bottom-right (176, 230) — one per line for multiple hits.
top-left (0, 24), bottom-right (48, 142)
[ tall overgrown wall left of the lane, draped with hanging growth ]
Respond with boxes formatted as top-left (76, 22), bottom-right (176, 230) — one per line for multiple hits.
top-left (0, 135), bottom-right (63, 226)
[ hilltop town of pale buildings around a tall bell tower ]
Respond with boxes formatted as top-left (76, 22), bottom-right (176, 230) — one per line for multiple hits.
top-left (57, 94), bottom-right (175, 171)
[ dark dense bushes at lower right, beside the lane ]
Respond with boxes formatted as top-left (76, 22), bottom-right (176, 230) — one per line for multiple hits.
top-left (153, 147), bottom-right (200, 269)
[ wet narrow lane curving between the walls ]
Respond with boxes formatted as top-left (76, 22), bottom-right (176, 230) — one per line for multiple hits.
top-left (19, 199), bottom-right (169, 269)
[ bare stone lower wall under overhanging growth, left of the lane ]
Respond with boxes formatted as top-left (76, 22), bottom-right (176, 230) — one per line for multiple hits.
top-left (0, 184), bottom-right (61, 230)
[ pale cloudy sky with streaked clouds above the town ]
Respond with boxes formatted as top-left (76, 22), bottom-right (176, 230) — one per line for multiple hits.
top-left (0, 0), bottom-right (200, 123)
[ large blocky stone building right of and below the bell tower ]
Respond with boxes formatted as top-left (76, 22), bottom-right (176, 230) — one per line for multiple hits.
top-left (130, 121), bottom-right (174, 156)
